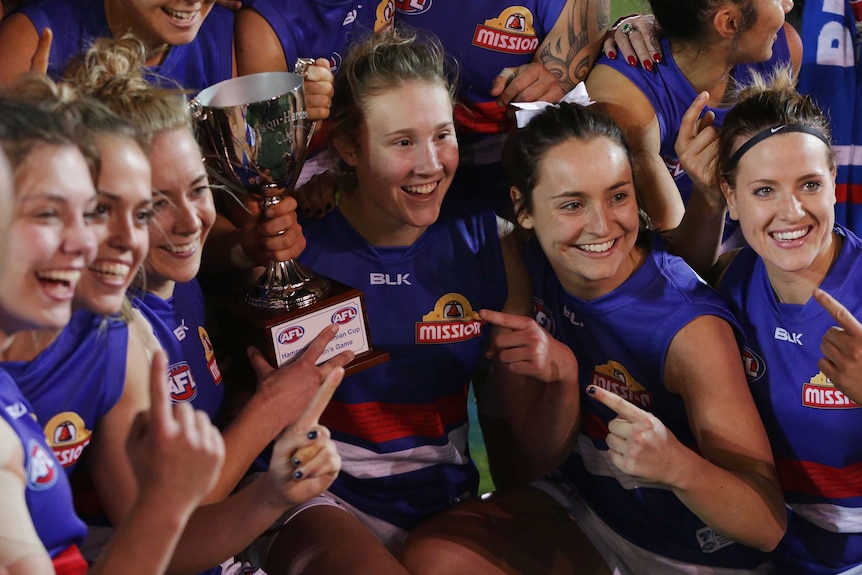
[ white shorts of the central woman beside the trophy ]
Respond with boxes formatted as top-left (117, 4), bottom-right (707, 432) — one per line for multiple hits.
top-left (242, 491), bottom-right (408, 565)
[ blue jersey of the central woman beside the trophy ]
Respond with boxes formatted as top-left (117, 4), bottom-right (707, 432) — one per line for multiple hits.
top-left (299, 210), bottom-right (507, 529)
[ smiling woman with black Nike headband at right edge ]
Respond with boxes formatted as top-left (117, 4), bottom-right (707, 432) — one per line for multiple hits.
top-left (718, 71), bottom-right (862, 574)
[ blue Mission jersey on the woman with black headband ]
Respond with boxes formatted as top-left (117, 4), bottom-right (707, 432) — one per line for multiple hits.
top-left (719, 227), bottom-right (862, 574)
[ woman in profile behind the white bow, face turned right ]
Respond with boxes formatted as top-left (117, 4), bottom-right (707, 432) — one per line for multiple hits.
top-left (587, 0), bottom-right (801, 236)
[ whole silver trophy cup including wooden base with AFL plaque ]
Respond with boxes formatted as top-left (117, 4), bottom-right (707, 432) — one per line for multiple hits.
top-left (190, 59), bottom-right (388, 374)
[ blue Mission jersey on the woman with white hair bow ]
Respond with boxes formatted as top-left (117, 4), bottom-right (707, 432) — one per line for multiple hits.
top-left (525, 238), bottom-right (766, 569)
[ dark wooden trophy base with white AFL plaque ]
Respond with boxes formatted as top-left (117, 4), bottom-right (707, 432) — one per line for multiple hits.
top-left (216, 279), bottom-right (389, 375)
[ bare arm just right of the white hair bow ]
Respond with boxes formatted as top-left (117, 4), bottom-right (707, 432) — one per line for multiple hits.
top-left (587, 65), bottom-right (685, 230)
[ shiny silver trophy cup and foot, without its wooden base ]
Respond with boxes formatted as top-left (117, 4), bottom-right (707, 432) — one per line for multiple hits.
top-left (189, 64), bottom-right (329, 310)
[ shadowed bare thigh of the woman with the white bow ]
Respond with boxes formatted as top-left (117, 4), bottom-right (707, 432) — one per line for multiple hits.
top-left (401, 487), bottom-right (610, 575)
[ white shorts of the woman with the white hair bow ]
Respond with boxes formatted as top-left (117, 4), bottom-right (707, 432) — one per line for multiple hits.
top-left (530, 477), bottom-right (772, 575)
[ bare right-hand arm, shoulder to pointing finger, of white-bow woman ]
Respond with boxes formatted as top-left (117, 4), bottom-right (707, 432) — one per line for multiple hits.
top-left (588, 316), bottom-right (786, 551)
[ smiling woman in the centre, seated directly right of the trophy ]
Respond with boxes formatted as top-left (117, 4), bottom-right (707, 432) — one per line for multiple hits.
top-left (231, 29), bottom-right (568, 574)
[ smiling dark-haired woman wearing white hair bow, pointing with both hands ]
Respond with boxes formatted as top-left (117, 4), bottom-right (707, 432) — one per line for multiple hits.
top-left (406, 104), bottom-right (785, 574)
